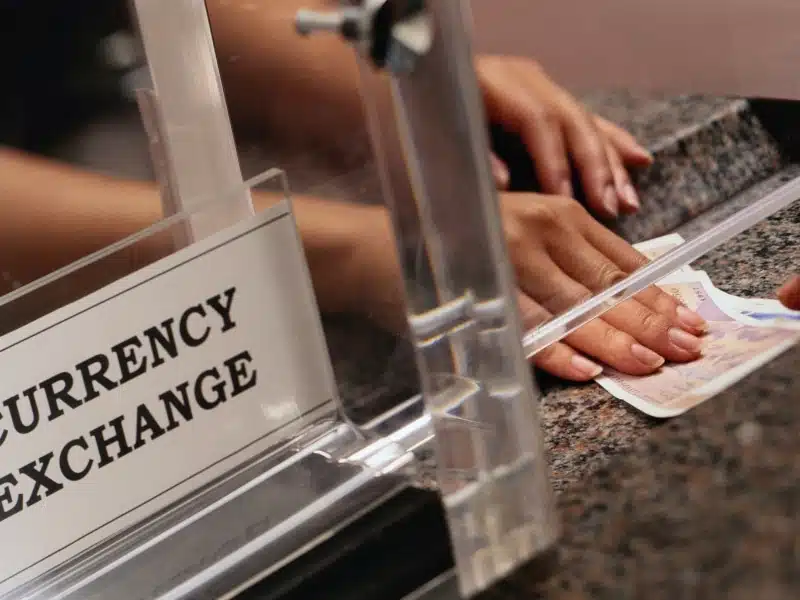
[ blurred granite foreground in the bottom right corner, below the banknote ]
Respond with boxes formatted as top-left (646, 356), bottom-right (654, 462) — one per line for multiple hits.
top-left (502, 347), bottom-right (800, 600)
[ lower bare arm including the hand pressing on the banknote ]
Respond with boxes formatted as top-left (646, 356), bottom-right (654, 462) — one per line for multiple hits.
top-left (0, 146), bottom-right (720, 381)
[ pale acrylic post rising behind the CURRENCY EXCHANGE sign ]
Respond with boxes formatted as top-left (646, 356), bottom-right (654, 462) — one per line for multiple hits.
top-left (133, 0), bottom-right (252, 238)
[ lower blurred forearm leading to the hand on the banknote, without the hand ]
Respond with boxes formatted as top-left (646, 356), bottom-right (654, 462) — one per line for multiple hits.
top-left (0, 148), bottom-right (390, 312)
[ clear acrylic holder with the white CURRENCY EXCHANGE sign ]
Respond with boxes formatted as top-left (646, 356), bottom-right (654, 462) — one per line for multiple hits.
top-left (0, 170), bottom-right (430, 600)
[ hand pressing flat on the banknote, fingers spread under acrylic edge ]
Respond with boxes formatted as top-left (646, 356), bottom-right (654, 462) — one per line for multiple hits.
top-left (501, 194), bottom-right (706, 381)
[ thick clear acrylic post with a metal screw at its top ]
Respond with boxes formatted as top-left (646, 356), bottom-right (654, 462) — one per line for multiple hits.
top-left (298, 0), bottom-right (558, 596)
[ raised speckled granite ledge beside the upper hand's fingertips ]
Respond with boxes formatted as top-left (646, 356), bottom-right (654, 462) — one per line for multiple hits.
top-left (586, 92), bottom-right (781, 242)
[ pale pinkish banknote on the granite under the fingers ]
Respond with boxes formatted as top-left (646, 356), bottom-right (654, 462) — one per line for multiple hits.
top-left (596, 277), bottom-right (800, 418)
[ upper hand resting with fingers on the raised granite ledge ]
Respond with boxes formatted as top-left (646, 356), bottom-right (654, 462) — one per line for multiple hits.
top-left (477, 56), bottom-right (653, 217)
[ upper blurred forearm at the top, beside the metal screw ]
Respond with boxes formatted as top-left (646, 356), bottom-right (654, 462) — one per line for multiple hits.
top-left (206, 0), bottom-right (363, 144)
